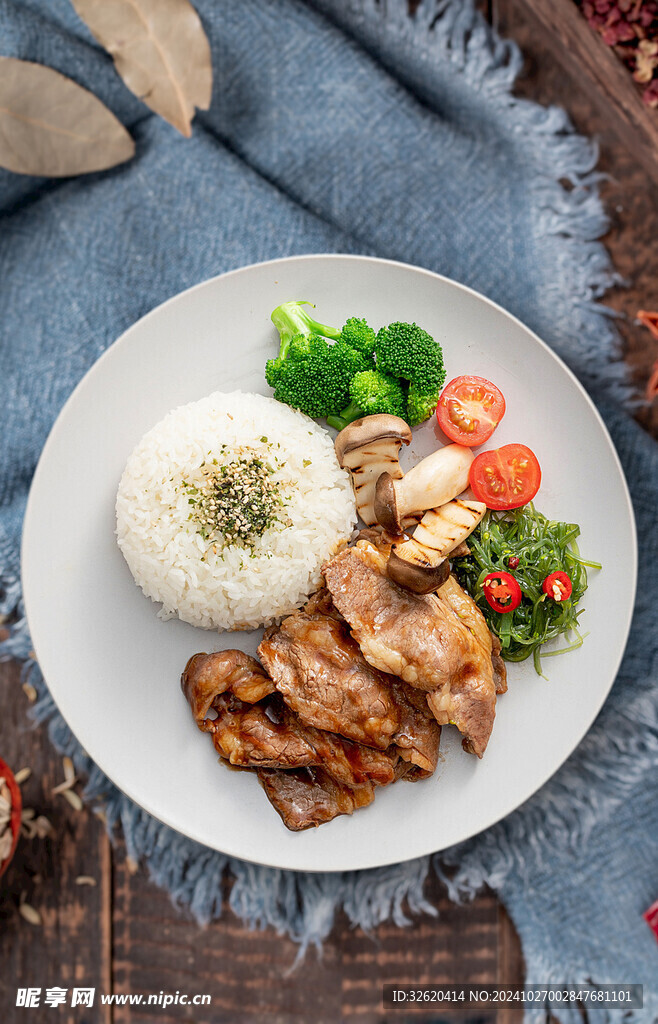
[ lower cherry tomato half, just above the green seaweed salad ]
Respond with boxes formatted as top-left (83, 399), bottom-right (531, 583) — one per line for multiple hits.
top-left (469, 444), bottom-right (541, 509)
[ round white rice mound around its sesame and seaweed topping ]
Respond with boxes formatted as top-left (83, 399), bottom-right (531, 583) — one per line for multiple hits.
top-left (117, 391), bottom-right (356, 630)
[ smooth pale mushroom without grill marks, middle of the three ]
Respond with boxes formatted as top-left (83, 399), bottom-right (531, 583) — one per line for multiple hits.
top-left (376, 435), bottom-right (474, 534)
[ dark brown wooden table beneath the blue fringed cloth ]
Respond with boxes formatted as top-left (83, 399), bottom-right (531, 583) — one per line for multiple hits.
top-left (0, 0), bottom-right (658, 1024)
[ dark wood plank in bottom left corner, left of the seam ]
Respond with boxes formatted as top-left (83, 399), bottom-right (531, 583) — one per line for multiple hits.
top-left (0, 664), bottom-right (112, 1024)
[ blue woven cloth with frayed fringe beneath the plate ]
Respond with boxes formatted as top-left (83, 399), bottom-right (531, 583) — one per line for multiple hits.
top-left (0, 0), bottom-right (658, 1024)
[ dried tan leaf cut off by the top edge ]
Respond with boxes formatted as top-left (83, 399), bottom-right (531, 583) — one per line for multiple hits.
top-left (72, 0), bottom-right (213, 136)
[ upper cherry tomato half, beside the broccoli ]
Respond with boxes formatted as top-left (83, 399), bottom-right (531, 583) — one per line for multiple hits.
top-left (436, 377), bottom-right (505, 447)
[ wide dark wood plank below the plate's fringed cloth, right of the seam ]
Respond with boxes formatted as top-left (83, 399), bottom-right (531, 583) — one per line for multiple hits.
top-left (114, 860), bottom-right (505, 1024)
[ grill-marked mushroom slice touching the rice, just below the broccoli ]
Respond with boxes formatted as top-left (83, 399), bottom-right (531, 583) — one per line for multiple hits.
top-left (335, 414), bottom-right (411, 532)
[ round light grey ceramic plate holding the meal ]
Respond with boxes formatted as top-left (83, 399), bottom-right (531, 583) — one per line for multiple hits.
top-left (23, 255), bottom-right (637, 870)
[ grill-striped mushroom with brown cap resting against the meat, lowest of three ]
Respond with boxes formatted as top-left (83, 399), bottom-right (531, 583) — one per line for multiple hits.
top-left (386, 499), bottom-right (486, 594)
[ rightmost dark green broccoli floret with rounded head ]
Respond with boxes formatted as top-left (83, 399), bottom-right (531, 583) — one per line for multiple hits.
top-left (375, 323), bottom-right (445, 392)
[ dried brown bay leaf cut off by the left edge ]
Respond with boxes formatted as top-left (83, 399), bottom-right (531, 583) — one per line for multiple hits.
top-left (0, 57), bottom-right (135, 177)
